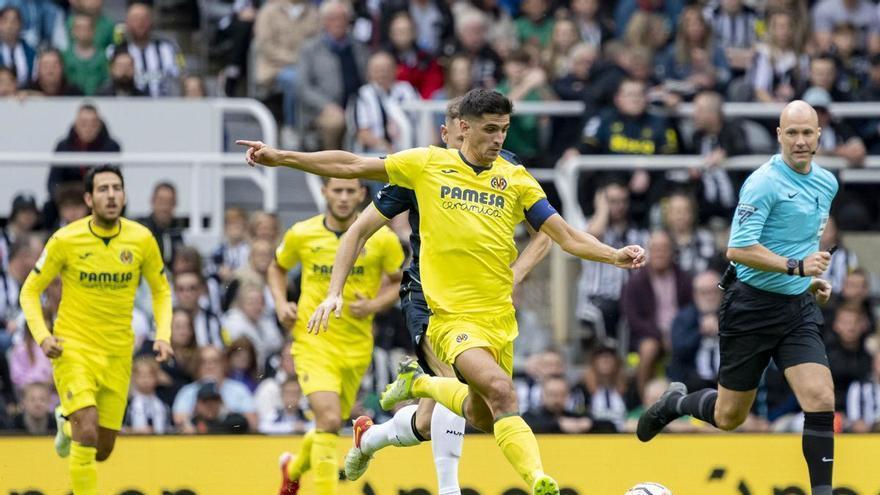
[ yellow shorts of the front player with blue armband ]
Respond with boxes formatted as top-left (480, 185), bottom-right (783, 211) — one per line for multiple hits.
top-left (427, 309), bottom-right (519, 375)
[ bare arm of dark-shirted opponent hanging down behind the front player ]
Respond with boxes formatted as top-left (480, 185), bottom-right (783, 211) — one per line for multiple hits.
top-left (308, 203), bottom-right (390, 332)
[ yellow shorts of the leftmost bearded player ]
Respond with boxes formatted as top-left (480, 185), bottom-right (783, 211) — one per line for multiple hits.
top-left (52, 349), bottom-right (131, 431)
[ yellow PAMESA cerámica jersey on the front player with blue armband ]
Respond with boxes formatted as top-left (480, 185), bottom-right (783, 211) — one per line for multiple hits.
top-left (385, 146), bottom-right (546, 314)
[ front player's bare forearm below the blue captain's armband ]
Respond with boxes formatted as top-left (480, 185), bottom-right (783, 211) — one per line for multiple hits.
top-left (541, 214), bottom-right (645, 269)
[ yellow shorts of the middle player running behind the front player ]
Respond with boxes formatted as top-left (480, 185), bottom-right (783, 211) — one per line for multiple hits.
top-left (291, 343), bottom-right (372, 421)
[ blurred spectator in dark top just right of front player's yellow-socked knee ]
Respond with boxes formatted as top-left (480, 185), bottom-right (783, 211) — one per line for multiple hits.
top-left (522, 376), bottom-right (593, 433)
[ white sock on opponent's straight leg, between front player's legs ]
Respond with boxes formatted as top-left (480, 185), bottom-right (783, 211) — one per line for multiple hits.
top-left (431, 403), bottom-right (465, 495)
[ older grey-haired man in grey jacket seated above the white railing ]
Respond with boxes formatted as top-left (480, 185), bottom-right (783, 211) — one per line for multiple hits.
top-left (297, 0), bottom-right (369, 149)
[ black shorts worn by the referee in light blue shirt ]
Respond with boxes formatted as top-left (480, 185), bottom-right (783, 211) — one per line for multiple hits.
top-left (718, 280), bottom-right (828, 392)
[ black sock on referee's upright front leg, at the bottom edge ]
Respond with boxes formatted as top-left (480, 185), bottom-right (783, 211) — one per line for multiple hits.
top-left (803, 411), bottom-right (834, 495)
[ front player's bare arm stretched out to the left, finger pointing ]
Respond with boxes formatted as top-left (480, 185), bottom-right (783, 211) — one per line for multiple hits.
top-left (235, 139), bottom-right (388, 182)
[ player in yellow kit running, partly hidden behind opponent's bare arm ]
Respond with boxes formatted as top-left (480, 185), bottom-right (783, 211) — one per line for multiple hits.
top-left (268, 179), bottom-right (404, 495)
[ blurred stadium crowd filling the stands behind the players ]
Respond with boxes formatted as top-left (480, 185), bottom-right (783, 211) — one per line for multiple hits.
top-left (0, 0), bottom-right (880, 434)
